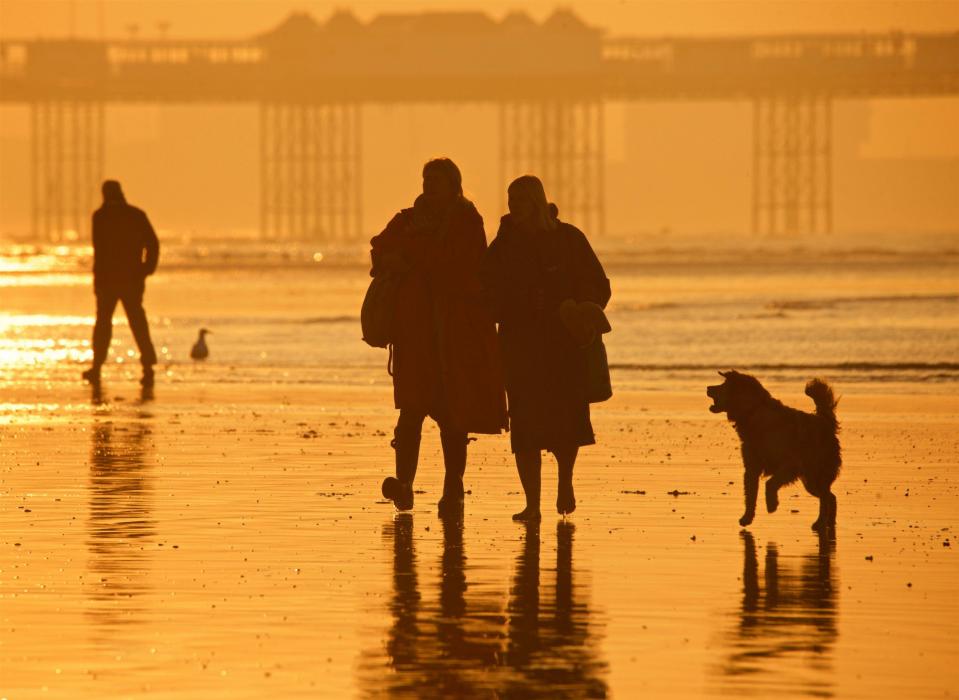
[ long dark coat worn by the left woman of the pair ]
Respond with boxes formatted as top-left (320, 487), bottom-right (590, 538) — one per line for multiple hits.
top-left (370, 199), bottom-right (508, 433)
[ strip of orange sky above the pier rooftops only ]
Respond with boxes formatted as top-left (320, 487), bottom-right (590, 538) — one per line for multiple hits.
top-left (0, 0), bottom-right (959, 37)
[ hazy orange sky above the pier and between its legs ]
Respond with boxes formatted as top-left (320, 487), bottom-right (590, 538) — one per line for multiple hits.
top-left (0, 0), bottom-right (959, 236)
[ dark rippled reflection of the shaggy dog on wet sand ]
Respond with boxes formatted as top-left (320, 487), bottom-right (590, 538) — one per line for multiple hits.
top-left (724, 531), bottom-right (839, 694)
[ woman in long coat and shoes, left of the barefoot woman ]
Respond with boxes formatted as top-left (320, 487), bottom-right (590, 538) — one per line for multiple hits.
top-left (371, 158), bottom-right (507, 513)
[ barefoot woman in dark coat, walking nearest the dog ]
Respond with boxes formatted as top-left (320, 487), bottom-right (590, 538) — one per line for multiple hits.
top-left (481, 175), bottom-right (610, 520)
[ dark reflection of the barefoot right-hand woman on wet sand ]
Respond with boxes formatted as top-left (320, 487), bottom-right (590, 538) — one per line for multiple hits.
top-left (506, 520), bottom-right (607, 698)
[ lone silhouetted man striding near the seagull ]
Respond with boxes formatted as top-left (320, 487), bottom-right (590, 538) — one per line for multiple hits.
top-left (83, 180), bottom-right (160, 386)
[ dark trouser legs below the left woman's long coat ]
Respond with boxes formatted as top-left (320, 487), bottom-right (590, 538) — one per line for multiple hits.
top-left (392, 409), bottom-right (468, 498)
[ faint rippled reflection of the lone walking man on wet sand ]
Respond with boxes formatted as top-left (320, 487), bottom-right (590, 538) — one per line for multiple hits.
top-left (87, 421), bottom-right (155, 628)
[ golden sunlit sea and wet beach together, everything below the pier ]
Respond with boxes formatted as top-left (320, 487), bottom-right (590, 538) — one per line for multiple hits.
top-left (0, 234), bottom-right (959, 699)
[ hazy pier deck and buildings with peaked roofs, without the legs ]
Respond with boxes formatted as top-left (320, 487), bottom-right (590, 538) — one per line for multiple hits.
top-left (0, 10), bottom-right (959, 102)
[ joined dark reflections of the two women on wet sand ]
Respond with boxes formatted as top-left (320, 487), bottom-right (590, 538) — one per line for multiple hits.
top-left (378, 514), bottom-right (607, 697)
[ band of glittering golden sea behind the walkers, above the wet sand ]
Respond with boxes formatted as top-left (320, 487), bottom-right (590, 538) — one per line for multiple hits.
top-left (0, 237), bottom-right (959, 390)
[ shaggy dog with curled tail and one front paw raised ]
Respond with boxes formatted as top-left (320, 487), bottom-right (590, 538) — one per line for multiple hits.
top-left (706, 370), bottom-right (842, 532)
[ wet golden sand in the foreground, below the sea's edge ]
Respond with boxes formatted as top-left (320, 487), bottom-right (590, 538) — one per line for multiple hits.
top-left (0, 381), bottom-right (959, 698)
